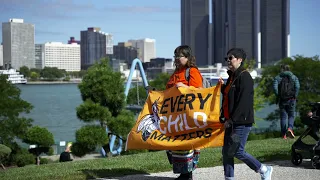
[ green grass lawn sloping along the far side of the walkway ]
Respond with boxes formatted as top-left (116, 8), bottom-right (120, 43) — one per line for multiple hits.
top-left (0, 138), bottom-right (294, 180)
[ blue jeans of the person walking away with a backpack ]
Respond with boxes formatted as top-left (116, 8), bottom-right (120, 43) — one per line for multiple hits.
top-left (279, 99), bottom-right (296, 136)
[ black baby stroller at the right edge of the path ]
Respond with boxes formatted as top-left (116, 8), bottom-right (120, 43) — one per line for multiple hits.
top-left (291, 102), bottom-right (320, 169)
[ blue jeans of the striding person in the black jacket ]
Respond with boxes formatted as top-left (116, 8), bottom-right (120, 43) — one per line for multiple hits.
top-left (222, 125), bottom-right (261, 177)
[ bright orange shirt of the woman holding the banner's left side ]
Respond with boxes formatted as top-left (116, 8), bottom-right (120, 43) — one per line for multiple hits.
top-left (166, 68), bottom-right (202, 89)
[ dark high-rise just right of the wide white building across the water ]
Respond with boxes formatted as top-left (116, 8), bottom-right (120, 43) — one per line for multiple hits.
top-left (80, 27), bottom-right (107, 69)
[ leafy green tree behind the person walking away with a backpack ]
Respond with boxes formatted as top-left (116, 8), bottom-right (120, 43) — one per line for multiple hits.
top-left (258, 56), bottom-right (320, 128)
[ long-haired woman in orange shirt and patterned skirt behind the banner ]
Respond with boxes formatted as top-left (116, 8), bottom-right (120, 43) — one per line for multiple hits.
top-left (166, 45), bottom-right (202, 180)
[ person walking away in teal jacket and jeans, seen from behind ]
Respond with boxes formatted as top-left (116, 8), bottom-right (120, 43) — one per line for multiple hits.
top-left (273, 65), bottom-right (300, 139)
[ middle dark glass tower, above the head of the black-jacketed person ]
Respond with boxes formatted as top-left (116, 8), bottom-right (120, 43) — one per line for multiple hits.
top-left (212, 0), bottom-right (258, 63)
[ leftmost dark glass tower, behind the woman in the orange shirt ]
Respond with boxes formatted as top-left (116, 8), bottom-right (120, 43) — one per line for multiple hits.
top-left (181, 0), bottom-right (209, 66)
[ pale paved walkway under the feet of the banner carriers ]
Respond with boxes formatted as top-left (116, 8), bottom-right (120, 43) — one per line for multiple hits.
top-left (100, 161), bottom-right (320, 180)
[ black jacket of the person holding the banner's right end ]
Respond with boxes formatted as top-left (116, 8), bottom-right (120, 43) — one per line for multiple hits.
top-left (220, 66), bottom-right (254, 125)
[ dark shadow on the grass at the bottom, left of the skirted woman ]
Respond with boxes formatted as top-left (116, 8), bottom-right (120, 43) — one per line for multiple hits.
top-left (82, 168), bottom-right (174, 180)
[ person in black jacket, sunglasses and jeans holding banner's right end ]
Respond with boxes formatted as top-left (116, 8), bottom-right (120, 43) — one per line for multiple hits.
top-left (219, 48), bottom-right (273, 180)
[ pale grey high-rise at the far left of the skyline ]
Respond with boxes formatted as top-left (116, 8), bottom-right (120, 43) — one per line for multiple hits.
top-left (2, 19), bottom-right (35, 69)
